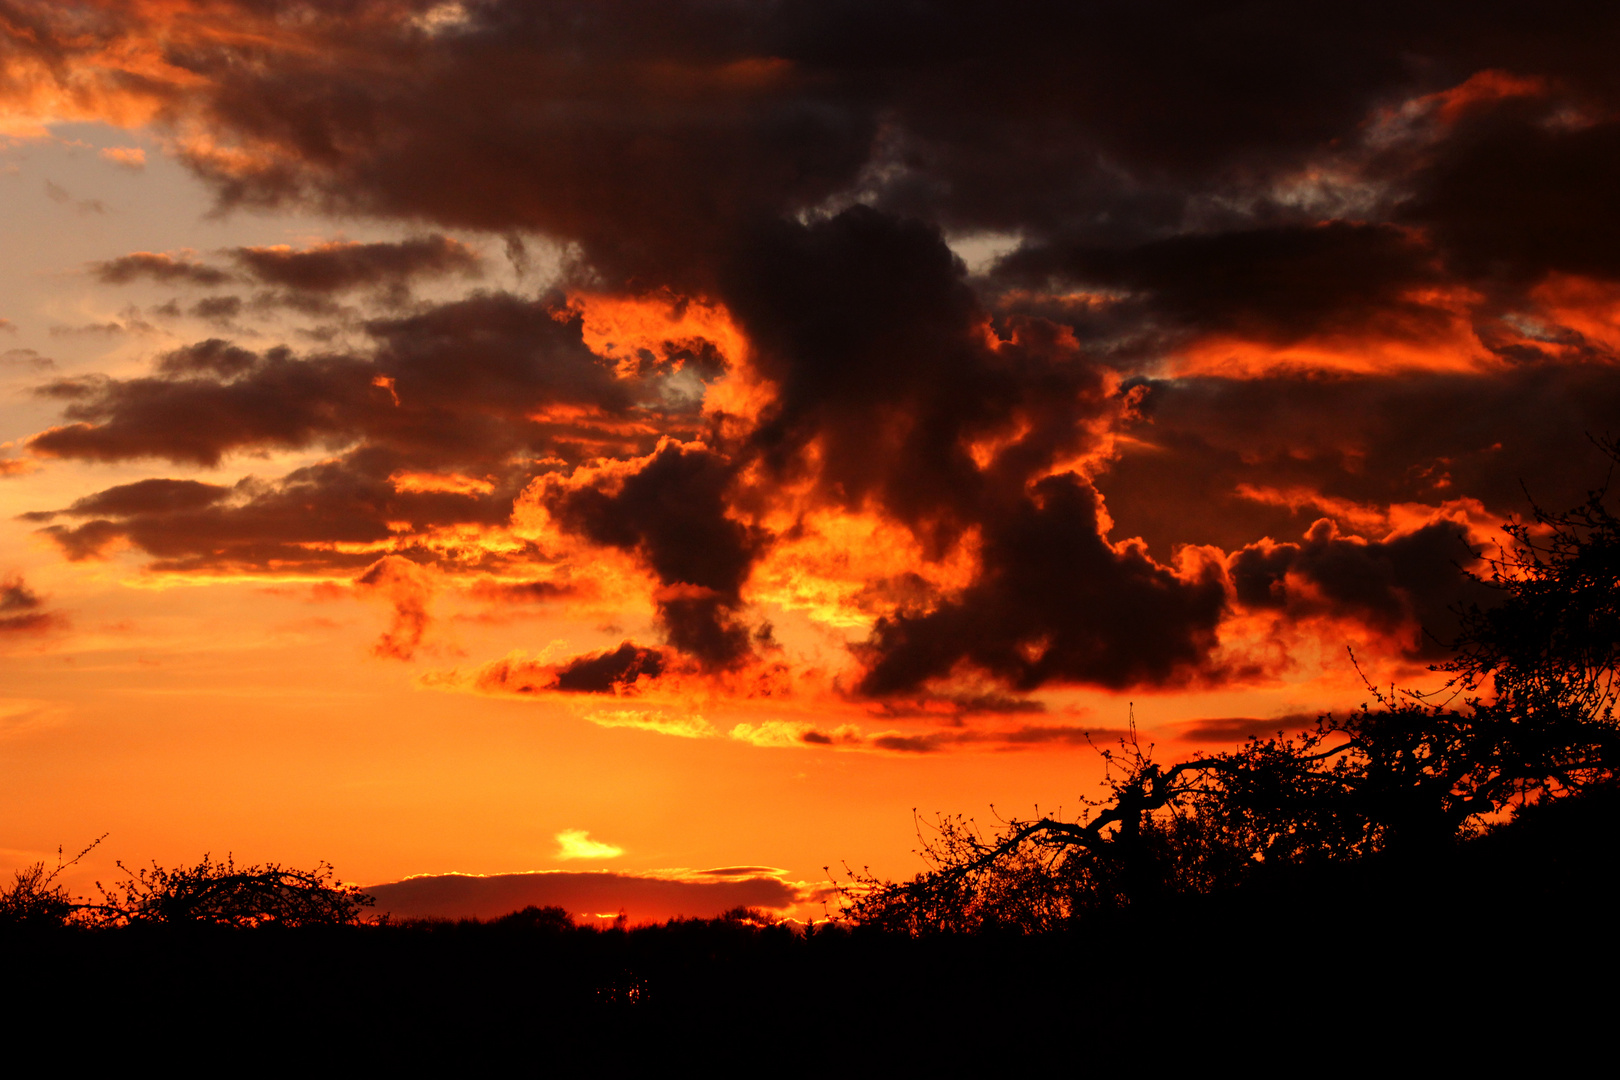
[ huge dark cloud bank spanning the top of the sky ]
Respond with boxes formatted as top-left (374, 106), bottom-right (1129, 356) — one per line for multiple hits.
top-left (19, 0), bottom-right (1620, 285)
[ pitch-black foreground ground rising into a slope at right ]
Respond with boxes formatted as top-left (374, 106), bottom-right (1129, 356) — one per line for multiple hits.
top-left (0, 797), bottom-right (1620, 1075)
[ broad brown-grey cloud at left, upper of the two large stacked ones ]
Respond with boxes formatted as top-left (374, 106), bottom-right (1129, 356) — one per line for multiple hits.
top-left (29, 295), bottom-right (632, 465)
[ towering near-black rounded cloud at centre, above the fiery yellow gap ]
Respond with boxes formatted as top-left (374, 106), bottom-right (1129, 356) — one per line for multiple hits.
top-left (726, 207), bottom-right (997, 540)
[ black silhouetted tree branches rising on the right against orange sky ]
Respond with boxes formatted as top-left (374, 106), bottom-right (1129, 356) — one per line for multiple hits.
top-left (844, 442), bottom-right (1620, 933)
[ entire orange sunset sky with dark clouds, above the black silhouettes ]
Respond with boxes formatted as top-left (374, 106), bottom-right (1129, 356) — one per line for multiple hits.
top-left (0, 0), bottom-right (1620, 912)
